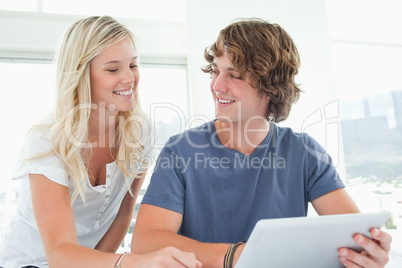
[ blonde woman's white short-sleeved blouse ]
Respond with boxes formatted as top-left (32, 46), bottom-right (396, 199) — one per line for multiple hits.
top-left (0, 124), bottom-right (152, 268)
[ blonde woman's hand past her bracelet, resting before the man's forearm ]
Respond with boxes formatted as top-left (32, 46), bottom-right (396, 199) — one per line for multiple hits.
top-left (125, 247), bottom-right (202, 268)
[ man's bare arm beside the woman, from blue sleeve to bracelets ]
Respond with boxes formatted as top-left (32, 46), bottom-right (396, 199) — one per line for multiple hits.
top-left (131, 204), bottom-right (230, 268)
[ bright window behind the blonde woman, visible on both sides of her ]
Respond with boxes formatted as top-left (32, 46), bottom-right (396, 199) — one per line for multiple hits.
top-left (0, 61), bottom-right (188, 252)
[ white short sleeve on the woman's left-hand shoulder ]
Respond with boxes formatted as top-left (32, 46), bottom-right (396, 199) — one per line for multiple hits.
top-left (13, 129), bottom-right (68, 187)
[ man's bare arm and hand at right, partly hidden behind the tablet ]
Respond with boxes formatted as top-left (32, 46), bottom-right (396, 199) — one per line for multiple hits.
top-left (312, 188), bottom-right (392, 267)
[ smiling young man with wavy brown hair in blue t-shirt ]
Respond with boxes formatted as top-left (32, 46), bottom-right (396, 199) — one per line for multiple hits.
top-left (132, 19), bottom-right (391, 268)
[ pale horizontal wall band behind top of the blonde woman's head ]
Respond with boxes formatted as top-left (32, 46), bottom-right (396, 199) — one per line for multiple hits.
top-left (0, 11), bottom-right (186, 64)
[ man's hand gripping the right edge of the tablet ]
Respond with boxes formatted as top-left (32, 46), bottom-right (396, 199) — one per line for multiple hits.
top-left (338, 228), bottom-right (392, 268)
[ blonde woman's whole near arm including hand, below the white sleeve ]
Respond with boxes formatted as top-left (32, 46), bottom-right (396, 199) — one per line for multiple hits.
top-left (29, 174), bottom-right (201, 268)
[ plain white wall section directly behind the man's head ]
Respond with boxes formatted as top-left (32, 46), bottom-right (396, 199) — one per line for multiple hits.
top-left (186, 0), bottom-right (341, 172)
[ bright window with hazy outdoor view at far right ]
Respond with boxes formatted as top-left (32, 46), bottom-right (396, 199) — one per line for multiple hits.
top-left (326, 0), bottom-right (402, 239)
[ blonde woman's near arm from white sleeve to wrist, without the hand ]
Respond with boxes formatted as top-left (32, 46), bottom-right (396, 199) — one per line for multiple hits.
top-left (29, 174), bottom-right (118, 268)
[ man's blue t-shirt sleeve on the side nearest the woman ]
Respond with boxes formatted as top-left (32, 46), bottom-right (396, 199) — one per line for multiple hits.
top-left (142, 141), bottom-right (185, 214)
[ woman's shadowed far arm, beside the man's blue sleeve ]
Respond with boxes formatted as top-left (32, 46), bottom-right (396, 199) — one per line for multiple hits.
top-left (95, 171), bottom-right (147, 252)
